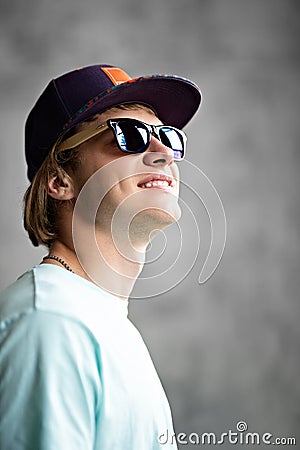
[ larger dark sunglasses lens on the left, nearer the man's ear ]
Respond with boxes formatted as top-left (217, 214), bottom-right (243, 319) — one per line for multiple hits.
top-left (114, 120), bottom-right (149, 153)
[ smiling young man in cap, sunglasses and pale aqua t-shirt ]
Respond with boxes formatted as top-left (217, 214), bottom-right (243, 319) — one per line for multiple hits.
top-left (0, 65), bottom-right (201, 450)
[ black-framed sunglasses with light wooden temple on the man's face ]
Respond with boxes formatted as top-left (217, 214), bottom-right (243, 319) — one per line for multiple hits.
top-left (58, 118), bottom-right (187, 161)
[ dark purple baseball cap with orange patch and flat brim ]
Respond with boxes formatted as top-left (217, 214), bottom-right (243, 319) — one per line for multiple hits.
top-left (25, 64), bottom-right (201, 181)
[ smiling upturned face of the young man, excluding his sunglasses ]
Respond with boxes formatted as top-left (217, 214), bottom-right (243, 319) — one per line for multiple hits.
top-left (73, 109), bottom-right (180, 243)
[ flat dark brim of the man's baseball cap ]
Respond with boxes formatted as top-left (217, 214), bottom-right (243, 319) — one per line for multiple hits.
top-left (65, 75), bottom-right (201, 131)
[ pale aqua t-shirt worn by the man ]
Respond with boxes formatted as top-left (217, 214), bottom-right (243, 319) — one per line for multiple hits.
top-left (0, 264), bottom-right (177, 450)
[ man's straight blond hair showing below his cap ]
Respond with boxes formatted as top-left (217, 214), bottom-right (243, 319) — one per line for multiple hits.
top-left (24, 103), bottom-right (155, 247)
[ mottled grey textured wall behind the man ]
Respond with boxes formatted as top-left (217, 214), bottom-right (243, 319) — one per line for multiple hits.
top-left (0, 0), bottom-right (300, 449)
